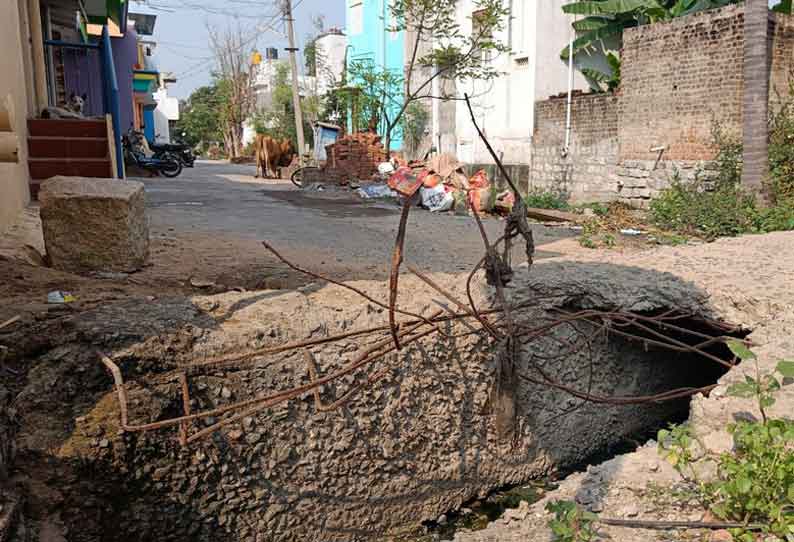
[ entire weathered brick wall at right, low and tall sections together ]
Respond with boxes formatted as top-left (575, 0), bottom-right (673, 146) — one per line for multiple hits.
top-left (530, 5), bottom-right (794, 207)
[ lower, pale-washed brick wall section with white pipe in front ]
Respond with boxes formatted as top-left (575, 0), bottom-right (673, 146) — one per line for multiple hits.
top-left (529, 94), bottom-right (618, 201)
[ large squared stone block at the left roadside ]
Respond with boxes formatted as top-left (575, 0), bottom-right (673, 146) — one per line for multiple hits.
top-left (39, 177), bottom-right (149, 273)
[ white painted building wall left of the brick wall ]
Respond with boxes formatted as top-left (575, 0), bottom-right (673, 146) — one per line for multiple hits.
top-left (456, 0), bottom-right (588, 164)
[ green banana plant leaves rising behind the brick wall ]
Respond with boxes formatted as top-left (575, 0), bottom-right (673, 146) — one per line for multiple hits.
top-left (560, 0), bottom-right (740, 91)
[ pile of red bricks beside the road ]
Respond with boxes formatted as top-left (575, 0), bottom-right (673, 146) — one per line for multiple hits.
top-left (324, 132), bottom-right (386, 184)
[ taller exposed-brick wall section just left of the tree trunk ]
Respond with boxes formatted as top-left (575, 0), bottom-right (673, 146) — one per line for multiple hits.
top-left (620, 6), bottom-right (744, 160)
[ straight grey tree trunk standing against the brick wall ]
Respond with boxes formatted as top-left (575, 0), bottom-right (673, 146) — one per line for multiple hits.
top-left (742, 0), bottom-right (770, 203)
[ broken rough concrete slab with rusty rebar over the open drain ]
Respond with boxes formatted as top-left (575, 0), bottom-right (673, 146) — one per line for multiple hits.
top-left (1, 251), bottom-right (732, 541)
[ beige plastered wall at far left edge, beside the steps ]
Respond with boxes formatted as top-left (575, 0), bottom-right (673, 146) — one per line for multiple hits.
top-left (0, 0), bottom-right (32, 233)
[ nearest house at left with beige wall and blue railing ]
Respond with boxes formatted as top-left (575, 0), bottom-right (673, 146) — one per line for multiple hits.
top-left (0, 0), bottom-right (128, 232)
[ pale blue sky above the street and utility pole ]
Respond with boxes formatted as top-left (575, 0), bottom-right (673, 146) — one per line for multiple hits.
top-left (130, 0), bottom-right (345, 98)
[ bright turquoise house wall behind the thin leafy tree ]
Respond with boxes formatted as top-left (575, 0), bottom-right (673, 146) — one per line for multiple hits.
top-left (345, 0), bottom-right (405, 150)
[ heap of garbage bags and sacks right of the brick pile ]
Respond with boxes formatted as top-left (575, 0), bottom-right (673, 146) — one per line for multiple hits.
top-left (358, 154), bottom-right (515, 214)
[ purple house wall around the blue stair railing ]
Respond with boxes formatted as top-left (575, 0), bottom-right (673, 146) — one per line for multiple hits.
top-left (62, 28), bottom-right (138, 132)
